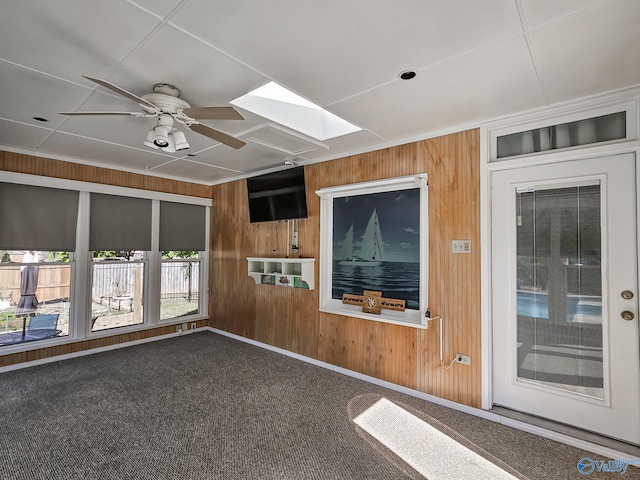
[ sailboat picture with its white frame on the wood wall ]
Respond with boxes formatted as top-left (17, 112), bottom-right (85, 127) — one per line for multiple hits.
top-left (316, 174), bottom-right (428, 326)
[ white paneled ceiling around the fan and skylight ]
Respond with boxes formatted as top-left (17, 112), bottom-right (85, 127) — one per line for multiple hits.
top-left (0, 0), bottom-right (640, 184)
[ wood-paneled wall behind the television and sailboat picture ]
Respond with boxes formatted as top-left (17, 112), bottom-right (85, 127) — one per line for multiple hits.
top-left (209, 129), bottom-right (481, 407)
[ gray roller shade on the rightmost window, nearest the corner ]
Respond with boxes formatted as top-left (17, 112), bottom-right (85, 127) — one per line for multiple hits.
top-left (160, 202), bottom-right (207, 251)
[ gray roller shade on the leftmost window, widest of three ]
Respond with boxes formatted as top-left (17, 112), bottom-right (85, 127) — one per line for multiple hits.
top-left (0, 183), bottom-right (79, 252)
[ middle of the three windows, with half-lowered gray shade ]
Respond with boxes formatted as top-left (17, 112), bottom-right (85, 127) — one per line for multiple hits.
top-left (89, 193), bottom-right (152, 332)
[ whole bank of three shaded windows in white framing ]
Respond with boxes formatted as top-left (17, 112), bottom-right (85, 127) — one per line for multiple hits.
top-left (0, 172), bottom-right (211, 353)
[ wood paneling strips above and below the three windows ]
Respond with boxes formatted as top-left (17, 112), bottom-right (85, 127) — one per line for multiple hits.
top-left (0, 151), bottom-right (211, 367)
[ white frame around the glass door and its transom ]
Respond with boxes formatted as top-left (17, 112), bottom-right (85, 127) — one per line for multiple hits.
top-left (480, 88), bottom-right (640, 410)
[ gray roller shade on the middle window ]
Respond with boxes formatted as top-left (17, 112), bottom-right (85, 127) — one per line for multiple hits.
top-left (89, 193), bottom-right (151, 251)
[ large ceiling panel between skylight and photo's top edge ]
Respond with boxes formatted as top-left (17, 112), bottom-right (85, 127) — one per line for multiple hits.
top-left (171, 0), bottom-right (521, 106)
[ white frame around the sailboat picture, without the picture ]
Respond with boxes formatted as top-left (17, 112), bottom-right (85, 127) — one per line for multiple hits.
top-left (316, 173), bottom-right (429, 328)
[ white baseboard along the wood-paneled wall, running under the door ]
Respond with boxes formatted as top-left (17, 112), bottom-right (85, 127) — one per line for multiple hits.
top-left (204, 327), bottom-right (640, 467)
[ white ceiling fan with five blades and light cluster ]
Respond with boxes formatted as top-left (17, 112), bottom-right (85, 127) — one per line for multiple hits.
top-left (59, 75), bottom-right (246, 153)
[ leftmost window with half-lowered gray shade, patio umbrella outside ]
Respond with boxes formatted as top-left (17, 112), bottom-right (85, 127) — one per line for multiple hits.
top-left (0, 182), bottom-right (79, 347)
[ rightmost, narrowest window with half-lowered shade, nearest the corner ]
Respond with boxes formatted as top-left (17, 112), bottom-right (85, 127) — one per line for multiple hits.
top-left (159, 201), bottom-right (207, 320)
